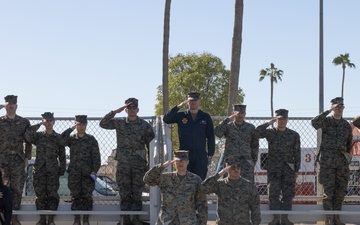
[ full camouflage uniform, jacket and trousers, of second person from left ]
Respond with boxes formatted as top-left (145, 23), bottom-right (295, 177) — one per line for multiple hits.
top-left (25, 124), bottom-right (66, 210)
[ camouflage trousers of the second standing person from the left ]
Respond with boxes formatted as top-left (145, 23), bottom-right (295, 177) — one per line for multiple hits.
top-left (33, 168), bottom-right (60, 210)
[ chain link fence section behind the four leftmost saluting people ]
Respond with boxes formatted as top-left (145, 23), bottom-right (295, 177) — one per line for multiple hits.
top-left (23, 117), bottom-right (156, 204)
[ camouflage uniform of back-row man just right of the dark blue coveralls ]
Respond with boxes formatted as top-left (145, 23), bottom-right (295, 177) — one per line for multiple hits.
top-left (214, 118), bottom-right (259, 182)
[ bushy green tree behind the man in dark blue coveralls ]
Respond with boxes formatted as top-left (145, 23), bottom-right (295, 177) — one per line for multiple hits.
top-left (155, 53), bottom-right (245, 116)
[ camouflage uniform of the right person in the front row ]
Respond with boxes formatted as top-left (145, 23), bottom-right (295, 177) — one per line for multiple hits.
top-left (200, 173), bottom-right (261, 225)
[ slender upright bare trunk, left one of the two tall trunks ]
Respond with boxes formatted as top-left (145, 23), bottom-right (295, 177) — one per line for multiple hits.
top-left (162, 0), bottom-right (171, 115)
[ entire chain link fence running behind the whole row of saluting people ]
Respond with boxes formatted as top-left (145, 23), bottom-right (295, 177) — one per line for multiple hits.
top-left (24, 117), bottom-right (360, 204)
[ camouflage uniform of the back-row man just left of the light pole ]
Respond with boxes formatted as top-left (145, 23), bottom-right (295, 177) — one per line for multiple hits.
top-left (256, 123), bottom-right (301, 210)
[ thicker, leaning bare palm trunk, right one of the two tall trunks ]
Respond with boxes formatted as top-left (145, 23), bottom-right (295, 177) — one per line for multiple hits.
top-left (227, 0), bottom-right (244, 115)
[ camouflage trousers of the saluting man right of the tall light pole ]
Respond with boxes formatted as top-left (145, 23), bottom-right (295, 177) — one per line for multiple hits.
top-left (319, 158), bottom-right (349, 210)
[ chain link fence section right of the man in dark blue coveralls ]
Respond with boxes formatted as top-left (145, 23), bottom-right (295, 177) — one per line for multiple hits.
top-left (209, 117), bottom-right (360, 200)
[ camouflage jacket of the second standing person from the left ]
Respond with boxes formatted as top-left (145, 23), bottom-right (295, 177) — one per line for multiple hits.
top-left (25, 124), bottom-right (66, 175)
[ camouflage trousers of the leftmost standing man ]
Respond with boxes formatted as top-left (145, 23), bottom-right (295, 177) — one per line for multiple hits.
top-left (1, 154), bottom-right (26, 210)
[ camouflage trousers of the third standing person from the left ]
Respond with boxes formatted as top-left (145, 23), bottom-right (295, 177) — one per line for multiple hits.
top-left (68, 172), bottom-right (95, 210)
